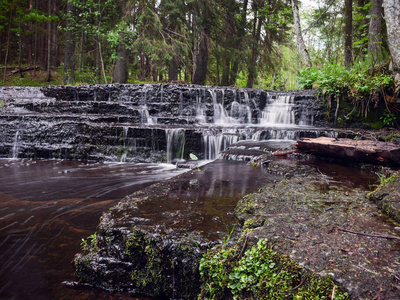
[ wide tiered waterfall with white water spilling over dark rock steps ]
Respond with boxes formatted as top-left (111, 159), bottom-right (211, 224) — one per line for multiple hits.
top-left (0, 84), bottom-right (329, 162)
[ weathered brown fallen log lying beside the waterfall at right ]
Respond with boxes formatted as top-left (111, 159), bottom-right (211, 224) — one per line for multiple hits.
top-left (296, 137), bottom-right (400, 165)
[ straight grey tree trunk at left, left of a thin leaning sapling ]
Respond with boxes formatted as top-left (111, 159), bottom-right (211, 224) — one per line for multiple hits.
top-left (63, 2), bottom-right (75, 84)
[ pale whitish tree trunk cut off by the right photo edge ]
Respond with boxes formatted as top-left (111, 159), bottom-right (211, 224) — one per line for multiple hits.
top-left (383, 0), bottom-right (400, 72)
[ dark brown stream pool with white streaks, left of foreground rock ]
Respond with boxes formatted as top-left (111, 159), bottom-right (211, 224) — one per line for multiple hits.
top-left (0, 160), bottom-right (182, 299)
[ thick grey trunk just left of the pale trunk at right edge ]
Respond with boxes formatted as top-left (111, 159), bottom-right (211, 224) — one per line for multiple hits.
top-left (368, 0), bottom-right (382, 59)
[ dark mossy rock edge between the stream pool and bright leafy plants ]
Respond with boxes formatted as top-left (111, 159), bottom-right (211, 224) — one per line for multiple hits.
top-left (74, 178), bottom-right (209, 299)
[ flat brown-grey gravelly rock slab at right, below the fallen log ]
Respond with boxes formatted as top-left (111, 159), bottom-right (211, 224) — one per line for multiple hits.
top-left (235, 161), bottom-right (400, 299)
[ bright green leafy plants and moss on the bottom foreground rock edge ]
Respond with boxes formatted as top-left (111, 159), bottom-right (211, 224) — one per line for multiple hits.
top-left (199, 239), bottom-right (348, 300)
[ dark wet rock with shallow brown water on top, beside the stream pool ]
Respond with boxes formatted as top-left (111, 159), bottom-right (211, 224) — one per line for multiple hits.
top-left (74, 160), bottom-right (280, 299)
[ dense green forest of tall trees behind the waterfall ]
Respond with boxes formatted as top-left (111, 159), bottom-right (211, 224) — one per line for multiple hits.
top-left (0, 0), bottom-right (400, 95)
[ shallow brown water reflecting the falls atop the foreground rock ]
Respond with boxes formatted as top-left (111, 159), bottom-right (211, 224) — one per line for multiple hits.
top-left (135, 160), bottom-right (281, 240)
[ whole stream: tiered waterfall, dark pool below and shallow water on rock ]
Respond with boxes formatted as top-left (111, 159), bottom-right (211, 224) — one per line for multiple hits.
top-left (0, 85), bottom-right (376, 300)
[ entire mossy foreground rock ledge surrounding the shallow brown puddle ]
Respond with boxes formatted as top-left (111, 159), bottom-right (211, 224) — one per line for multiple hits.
top-left (74, 154), bottom-right (400, 299)
